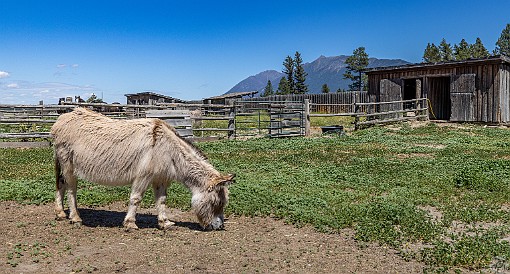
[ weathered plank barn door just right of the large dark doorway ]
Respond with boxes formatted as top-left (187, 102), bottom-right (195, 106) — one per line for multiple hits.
top-left (450, 74), bottom-right (476, 122)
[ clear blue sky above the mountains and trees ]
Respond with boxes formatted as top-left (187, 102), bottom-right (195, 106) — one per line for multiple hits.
top-left (0, 0), bottom-right (510, 104)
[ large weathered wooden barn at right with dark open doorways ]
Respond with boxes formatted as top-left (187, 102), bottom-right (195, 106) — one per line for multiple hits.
top-left (366, 56), bottom-right (510, 123)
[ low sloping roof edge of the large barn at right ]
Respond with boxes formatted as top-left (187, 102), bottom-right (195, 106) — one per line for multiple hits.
top-left (365, 55), bottom-right (510, 74)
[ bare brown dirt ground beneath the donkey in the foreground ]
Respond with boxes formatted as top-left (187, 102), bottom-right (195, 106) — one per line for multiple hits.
top-left (0, 202), bottom-right (424, 273)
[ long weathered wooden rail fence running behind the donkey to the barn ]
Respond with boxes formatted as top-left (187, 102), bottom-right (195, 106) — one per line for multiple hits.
top-left (0, 97), bottom-right (428, 146)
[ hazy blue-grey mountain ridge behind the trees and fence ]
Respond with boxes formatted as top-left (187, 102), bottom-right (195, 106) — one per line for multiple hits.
top-left (225, 55), bottom-right (409, 95)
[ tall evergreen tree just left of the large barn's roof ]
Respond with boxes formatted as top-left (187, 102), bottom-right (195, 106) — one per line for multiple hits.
top-left (344, 47), bottom-right (368, 91)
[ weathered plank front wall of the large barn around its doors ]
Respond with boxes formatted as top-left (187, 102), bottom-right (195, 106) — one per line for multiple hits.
top-left (368, 59), bottom-right (510, 123)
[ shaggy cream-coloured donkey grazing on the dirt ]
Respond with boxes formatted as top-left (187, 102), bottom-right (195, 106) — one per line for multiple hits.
top-left (51, 108), bottom-right (235, 230)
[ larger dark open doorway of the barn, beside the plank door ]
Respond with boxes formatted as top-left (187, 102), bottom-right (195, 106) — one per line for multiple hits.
top-left (427, 77), bottom-right (452, 120)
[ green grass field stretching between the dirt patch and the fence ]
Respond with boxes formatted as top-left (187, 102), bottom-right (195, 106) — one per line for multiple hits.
top-left (0, 121), bottom-right (510, 271)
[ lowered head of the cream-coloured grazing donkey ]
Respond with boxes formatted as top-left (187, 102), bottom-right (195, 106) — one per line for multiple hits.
top-left (191, 174), bottom-right (235, 230)
